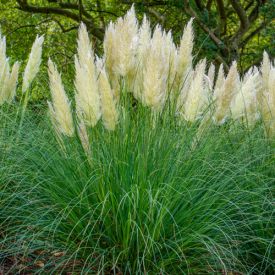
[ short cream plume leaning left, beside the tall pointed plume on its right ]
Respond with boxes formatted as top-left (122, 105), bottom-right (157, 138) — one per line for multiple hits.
top-left (48, 59), bottom-right (74, 137)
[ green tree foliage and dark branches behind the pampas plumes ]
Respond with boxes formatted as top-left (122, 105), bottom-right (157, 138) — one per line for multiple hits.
top-left (0, 0), bottom-right (275, 72)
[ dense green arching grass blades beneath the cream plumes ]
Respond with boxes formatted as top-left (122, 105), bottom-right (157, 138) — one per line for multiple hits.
top-left (0, 100), bottom-right (275, 274)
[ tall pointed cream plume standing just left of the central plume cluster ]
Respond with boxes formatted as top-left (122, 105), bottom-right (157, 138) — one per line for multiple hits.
top-left (75, 23), bottom-right (101, 126)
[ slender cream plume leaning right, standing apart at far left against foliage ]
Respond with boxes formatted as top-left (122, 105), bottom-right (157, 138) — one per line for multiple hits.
top-left (22, 35), bottom-right (44, 93)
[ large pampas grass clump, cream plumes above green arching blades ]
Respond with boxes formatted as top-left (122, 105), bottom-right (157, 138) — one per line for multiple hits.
top-left (0, 7), bottom-right (275, 274)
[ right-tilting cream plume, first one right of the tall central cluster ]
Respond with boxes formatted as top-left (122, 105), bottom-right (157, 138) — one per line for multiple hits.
top-left (184, 59), bottom-right (208, 121)
